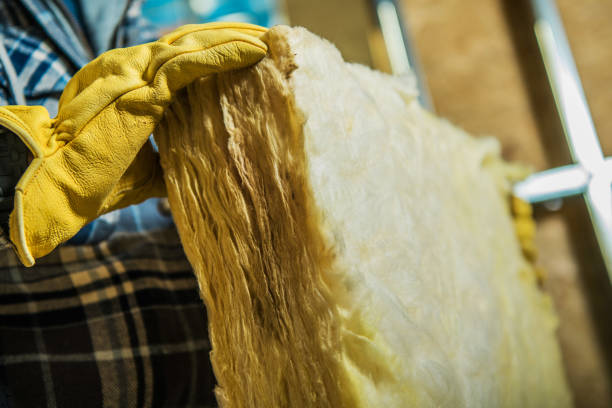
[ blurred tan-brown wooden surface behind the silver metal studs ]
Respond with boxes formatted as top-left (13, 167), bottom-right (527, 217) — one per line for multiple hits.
top-left (285, 0), bottom-right (612, 407)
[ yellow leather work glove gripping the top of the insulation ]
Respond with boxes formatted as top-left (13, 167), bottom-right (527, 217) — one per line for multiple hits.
top-left (0, 23), bottom-right (267, 266)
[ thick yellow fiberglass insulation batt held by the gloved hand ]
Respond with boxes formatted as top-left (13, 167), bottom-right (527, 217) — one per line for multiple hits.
top-left (156, 27), bottom-right (571, 407)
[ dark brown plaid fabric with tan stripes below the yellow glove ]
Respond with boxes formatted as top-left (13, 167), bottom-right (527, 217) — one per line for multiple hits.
top-left (0, 228), bottom-right (216, 407)
